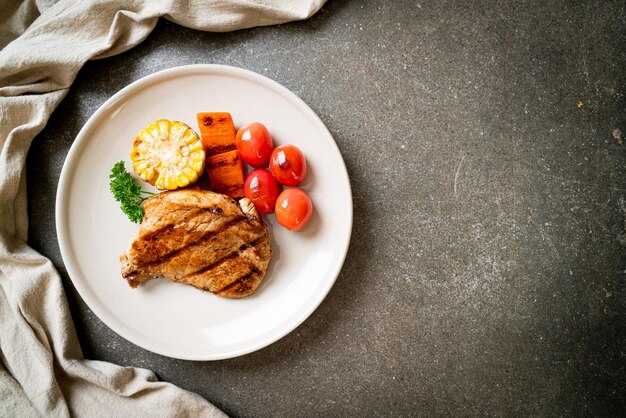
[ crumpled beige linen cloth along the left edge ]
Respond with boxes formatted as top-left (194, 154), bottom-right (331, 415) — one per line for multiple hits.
top-left (0, 0), bottom-right (324, 417)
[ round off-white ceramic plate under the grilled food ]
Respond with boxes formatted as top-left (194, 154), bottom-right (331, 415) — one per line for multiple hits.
top-left (56, 65), bottom-right (352, 360)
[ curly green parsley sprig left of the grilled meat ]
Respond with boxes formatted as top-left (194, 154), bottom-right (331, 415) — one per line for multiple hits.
top-left (109, 161), bottom-right (156, 223)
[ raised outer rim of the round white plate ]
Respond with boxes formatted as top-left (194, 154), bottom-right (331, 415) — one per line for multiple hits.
top-left (55, 64), bottom-right (354, 361)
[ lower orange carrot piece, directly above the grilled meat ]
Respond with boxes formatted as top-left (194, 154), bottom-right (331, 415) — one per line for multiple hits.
top-left (206, 150), bottom-right (246, 199)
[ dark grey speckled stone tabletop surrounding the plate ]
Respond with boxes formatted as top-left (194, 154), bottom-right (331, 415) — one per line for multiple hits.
top-left (28, 0), bottom-right (626, 416)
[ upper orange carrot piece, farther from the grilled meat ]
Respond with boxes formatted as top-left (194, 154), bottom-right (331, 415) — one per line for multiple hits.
top-left (196, 112), bottom-right (237, 156)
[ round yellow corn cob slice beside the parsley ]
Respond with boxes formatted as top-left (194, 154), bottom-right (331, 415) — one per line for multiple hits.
top-left (130, 119), bottom-right (205, 190)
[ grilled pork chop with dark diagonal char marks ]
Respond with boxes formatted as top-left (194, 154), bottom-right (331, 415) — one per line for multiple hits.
top-left (120, 189), bottom-right (272, 298)
